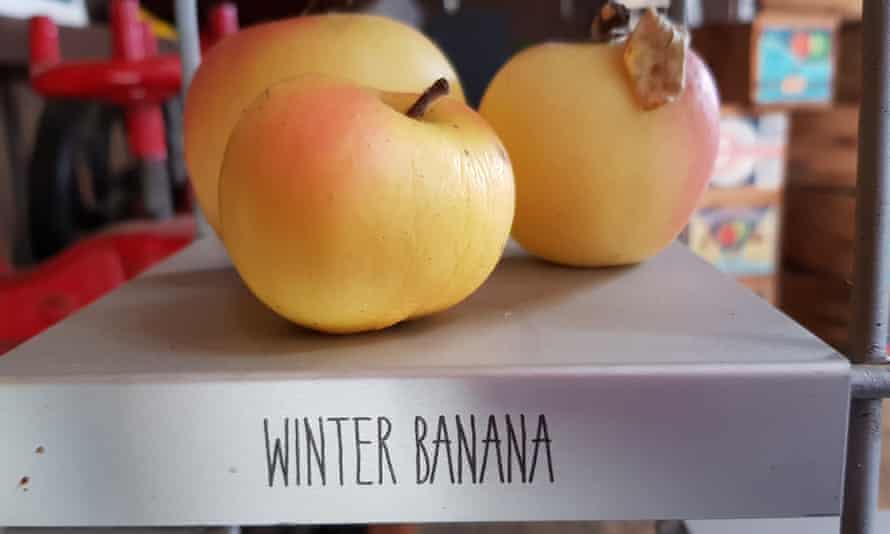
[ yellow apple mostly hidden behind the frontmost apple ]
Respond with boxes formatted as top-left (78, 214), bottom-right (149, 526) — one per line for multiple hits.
top-left (185, 14), bottom-right (463, 232)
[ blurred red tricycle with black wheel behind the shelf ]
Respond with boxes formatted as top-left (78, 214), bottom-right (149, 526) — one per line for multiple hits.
top-left (0, 0), bottom-right (238, 354)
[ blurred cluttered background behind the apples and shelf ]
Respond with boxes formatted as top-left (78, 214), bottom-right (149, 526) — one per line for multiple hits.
top-left (0, 0), bottom-right (861, 360)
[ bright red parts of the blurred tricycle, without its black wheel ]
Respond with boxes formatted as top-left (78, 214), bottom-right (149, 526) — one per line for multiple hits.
top-left (0, 0), bottom-right (238, 355)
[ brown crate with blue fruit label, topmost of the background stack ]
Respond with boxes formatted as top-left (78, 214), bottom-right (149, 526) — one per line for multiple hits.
top-left (692, 11), bottom-right (840, 109)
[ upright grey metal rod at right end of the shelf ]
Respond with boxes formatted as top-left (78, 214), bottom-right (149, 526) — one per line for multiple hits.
top-left (841, 4), bottom-right (890, 534)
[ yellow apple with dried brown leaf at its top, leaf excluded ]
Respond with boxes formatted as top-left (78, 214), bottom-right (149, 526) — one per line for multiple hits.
top-left (480, 43), bottom-right (720, 267)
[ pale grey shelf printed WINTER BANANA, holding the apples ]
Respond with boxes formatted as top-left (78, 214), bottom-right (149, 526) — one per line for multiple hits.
top-left (0, 238), bottom-right (849, 526)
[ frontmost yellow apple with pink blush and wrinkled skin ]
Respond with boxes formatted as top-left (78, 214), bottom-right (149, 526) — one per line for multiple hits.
top-left (220, 75), bottom-right (515, 333)
